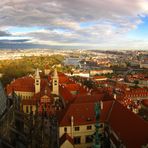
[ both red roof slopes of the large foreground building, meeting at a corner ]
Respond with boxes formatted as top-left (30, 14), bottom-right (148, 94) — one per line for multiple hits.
top-left (58, 100), bottom-right (148, 148)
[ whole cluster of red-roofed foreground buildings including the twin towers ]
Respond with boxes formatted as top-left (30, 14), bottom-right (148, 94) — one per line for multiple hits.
top-left (7, 69), bottom-right (148, 148)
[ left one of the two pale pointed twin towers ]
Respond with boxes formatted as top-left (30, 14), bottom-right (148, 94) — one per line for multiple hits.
top-left (35, 68), bottom-right (41, 93)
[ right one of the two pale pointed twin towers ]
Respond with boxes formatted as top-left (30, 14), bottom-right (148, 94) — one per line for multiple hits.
top-left (52, 68), bottom-right (59, 95)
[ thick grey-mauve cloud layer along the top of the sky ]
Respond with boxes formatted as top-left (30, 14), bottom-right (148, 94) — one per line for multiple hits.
top-left (0, 0), bottom-right (148, 26)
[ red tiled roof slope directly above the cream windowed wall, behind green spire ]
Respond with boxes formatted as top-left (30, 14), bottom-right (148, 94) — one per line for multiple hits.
top-left (58, 101), bottom-right (112, 126)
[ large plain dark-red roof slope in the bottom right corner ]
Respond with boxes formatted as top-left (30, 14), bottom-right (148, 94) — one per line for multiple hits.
top-left (108, 101), bottom-right (148, 148)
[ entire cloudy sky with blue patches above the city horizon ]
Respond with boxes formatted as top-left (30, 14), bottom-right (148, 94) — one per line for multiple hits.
top-left (0, 0), bottom-right (148, 50)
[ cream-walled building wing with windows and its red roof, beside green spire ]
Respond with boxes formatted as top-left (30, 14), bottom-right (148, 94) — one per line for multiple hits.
top-left (59, 102), bottom-right (104, 148)
